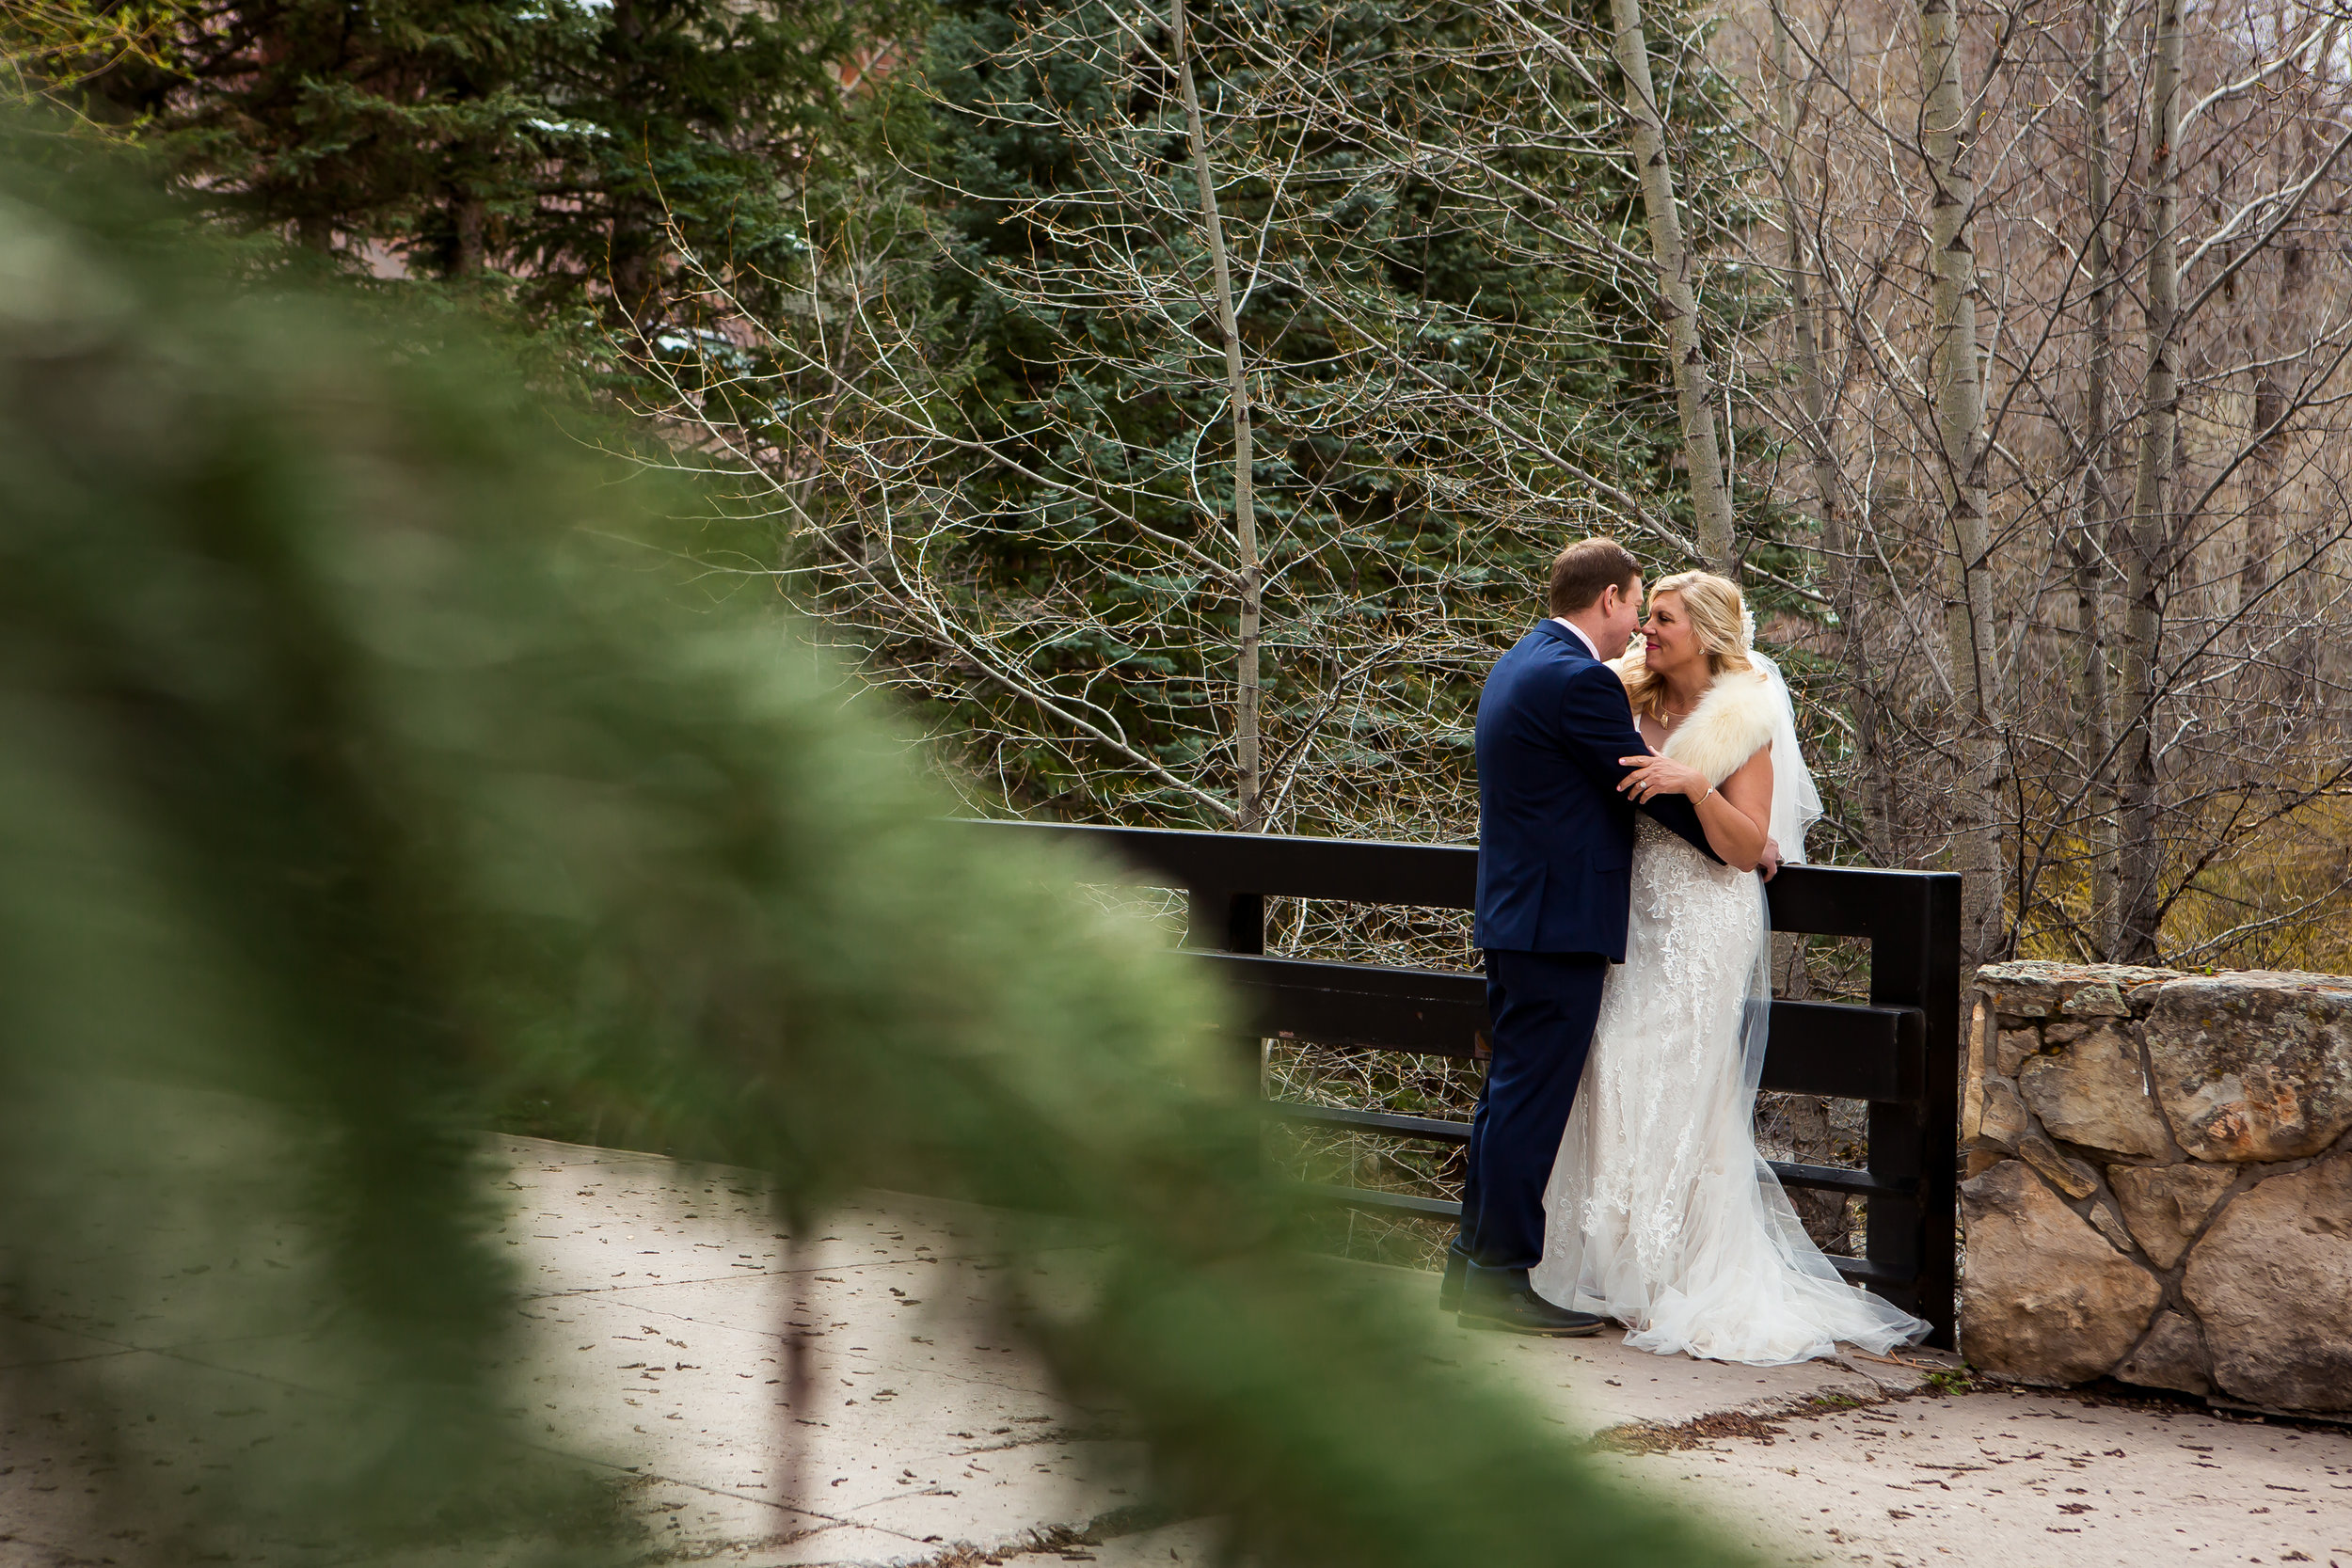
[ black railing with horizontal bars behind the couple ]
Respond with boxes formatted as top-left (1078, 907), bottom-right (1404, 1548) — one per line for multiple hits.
top-left (981, 823), bottom-right (1960, 1347)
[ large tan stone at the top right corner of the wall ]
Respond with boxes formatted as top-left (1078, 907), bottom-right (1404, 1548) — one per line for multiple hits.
top-left (2148, 971), bottom-right (2352, 1164)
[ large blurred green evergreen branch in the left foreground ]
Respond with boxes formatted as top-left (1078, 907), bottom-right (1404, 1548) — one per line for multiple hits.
top-left (0, 136), bottom-right (1726, 1568)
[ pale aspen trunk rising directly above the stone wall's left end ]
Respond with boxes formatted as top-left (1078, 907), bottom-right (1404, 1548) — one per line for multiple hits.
top-left (1919, 0), bottom-right (2007, 964)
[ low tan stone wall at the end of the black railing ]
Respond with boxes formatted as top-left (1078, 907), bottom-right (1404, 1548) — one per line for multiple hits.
top-left (1960, 961), bottom-right (2352, 1413)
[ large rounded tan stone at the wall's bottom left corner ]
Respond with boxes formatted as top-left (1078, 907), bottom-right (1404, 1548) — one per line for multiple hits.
top-left (1960, 1159), bottom-right (2162, 1383)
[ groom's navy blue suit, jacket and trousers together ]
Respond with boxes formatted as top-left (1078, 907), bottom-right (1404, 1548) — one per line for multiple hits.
top-left (1454, 621), bottom-right (1712, 1305)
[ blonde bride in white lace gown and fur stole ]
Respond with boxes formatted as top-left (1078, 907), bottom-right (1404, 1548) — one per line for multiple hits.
top-left (1532, 571), bottom-right (1929, 1366)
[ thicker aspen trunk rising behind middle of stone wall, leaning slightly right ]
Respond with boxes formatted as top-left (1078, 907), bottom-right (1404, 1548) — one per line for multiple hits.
top-left (2117, 0), bottom-right (2183, 964)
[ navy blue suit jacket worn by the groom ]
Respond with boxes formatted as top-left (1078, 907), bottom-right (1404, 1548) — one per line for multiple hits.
top-left (1470, 621), bottom-right (1720, 964)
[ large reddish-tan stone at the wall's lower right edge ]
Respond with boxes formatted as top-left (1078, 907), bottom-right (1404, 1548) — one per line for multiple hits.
top-left (2173, 1152), bottom-right (2352, 1411)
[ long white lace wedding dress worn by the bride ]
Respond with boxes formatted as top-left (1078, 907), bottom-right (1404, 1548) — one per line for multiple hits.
top-left (1532, 658), bottom-right (1929, 1366)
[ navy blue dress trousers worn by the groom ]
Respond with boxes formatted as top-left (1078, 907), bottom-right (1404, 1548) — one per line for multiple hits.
top-left (1454, 950), bottom-right (1609, 1291)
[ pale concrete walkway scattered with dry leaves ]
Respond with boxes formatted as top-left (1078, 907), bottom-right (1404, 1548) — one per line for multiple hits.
top-left (0, 1140), bottom-right (2352, 1568)
